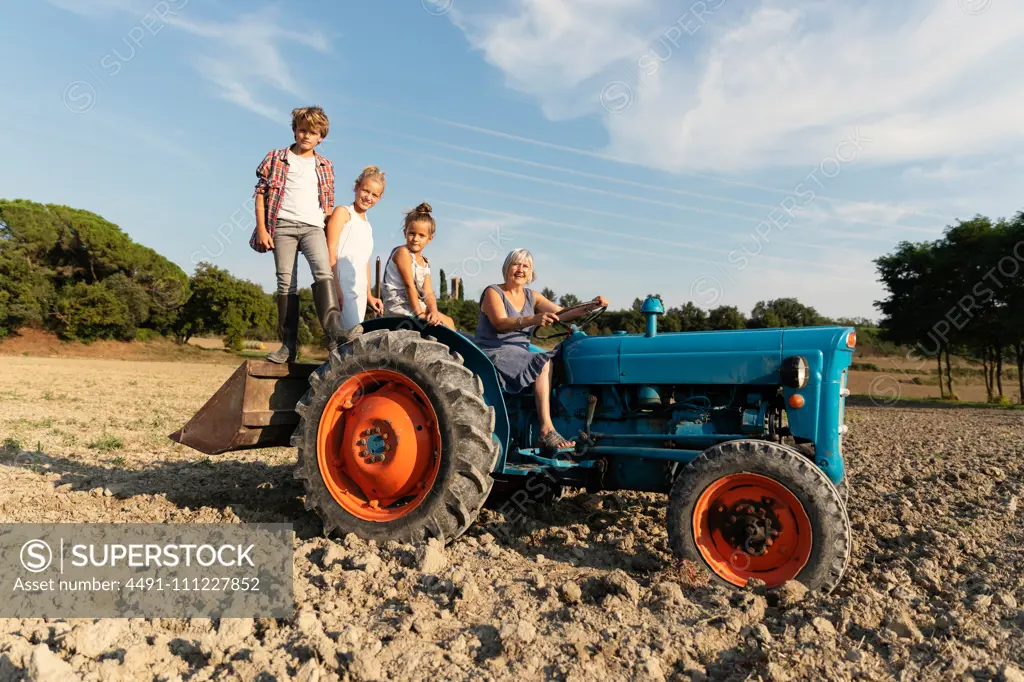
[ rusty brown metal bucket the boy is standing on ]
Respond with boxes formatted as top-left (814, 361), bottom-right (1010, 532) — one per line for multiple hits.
top-left (168, 359), bottom-right (319, 455)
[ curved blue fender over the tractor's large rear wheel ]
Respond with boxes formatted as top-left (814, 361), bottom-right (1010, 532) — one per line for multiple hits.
top-left (362, 317), bottom-right (509, 464)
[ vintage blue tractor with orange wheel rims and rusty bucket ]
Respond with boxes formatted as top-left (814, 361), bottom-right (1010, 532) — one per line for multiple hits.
top-left (171, 298), bottom-right (856, 592)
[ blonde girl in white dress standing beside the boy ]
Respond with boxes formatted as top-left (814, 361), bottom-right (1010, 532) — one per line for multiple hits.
top-left (327, 166), bottom-right (386, 329)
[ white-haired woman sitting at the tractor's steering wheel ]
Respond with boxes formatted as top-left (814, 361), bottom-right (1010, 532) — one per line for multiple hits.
top-left (476, 249), bottom-right (608, 451)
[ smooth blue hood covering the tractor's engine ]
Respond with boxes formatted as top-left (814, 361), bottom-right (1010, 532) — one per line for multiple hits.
top-left (563, 327), bottom-right (852, 386)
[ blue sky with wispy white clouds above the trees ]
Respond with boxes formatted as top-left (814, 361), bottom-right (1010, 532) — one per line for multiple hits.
top-left (0, 0), bottom-right (1024, 317)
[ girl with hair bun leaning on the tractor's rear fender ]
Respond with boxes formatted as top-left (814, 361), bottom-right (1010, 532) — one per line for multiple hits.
top-left (381, 202), bottom-right (455, 329)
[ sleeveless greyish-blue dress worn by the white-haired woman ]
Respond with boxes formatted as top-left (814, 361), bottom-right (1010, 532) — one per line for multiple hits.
top-left (474, 285), bottom-right (561, 394)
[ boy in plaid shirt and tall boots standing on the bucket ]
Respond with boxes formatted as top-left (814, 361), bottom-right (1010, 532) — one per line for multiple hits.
top-left (249, 106), bottom-right (362, 363)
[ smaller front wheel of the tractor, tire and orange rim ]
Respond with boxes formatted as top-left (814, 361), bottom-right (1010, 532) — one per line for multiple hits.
top-left (667, 440), bottom-right (852, 593)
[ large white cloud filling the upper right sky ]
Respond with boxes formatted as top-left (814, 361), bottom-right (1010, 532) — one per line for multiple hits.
top-left (455, 0), bottom-right (1024, 172)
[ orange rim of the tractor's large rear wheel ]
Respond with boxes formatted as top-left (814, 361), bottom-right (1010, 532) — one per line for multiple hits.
top-left (316, 370), bottom-right (441, 521)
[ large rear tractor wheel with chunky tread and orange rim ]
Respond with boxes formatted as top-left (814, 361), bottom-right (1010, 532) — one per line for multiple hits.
top-left (292, 330), bottom-right (499, 543)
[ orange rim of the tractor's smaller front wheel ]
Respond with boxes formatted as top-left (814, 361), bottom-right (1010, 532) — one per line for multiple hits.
top-left (693, 473), bottom-right (813, 588)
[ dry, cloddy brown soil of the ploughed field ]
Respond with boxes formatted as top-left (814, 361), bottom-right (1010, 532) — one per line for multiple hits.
top-left (0, 357), bottom-right (1024, 682)
